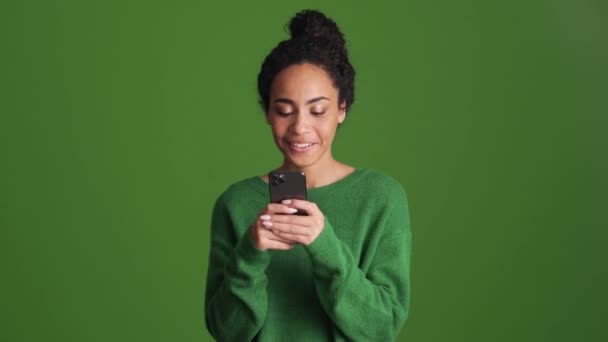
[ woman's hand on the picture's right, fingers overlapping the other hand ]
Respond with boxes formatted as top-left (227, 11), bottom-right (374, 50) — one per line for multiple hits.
top-left (260, 199), bottom-right (325, 246)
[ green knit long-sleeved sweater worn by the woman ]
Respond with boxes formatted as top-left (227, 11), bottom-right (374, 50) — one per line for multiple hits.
top-left (205, 168), bottom-right (411, 342)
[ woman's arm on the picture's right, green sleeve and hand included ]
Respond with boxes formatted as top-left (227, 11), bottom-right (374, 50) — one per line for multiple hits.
top-left (264, 188), bottom-right (411, 341)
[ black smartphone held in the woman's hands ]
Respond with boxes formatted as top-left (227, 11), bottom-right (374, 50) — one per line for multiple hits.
top-left (268, 171), bottom-right (308, 215)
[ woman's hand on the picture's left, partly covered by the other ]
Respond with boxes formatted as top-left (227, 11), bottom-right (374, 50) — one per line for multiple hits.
top-left (249, 203), bottom-right (296, 251)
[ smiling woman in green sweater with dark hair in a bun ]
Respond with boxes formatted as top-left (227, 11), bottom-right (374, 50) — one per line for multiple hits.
top-left (205, 10), bottom-right (411, 341)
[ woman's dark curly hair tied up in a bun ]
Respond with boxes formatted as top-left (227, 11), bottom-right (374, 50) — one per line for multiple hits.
top-left (258, 10), bottom-right (355, 112)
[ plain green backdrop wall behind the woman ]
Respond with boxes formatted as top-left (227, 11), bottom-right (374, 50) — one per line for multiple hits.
top-left (0, 0), bottom-right (608, 341)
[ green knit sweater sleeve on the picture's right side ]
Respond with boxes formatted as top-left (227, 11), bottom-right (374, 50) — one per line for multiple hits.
top-left (307, 194), bottom-right (411, 341)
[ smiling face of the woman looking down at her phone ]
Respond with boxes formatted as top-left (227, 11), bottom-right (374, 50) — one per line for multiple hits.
top-left (266, 63), bottom-right (346, 169)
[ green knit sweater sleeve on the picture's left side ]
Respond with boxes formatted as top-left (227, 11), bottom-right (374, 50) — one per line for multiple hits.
top-left (205, 197), bottom-right (270, 341)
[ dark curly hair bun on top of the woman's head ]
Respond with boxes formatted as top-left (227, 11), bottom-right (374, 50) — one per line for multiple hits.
top-left (289, 10), bottom-right (345, 49)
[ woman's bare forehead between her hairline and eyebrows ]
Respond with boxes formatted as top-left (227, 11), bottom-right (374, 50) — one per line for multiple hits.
top-left (270, 63), bottom-right (338, 102)
